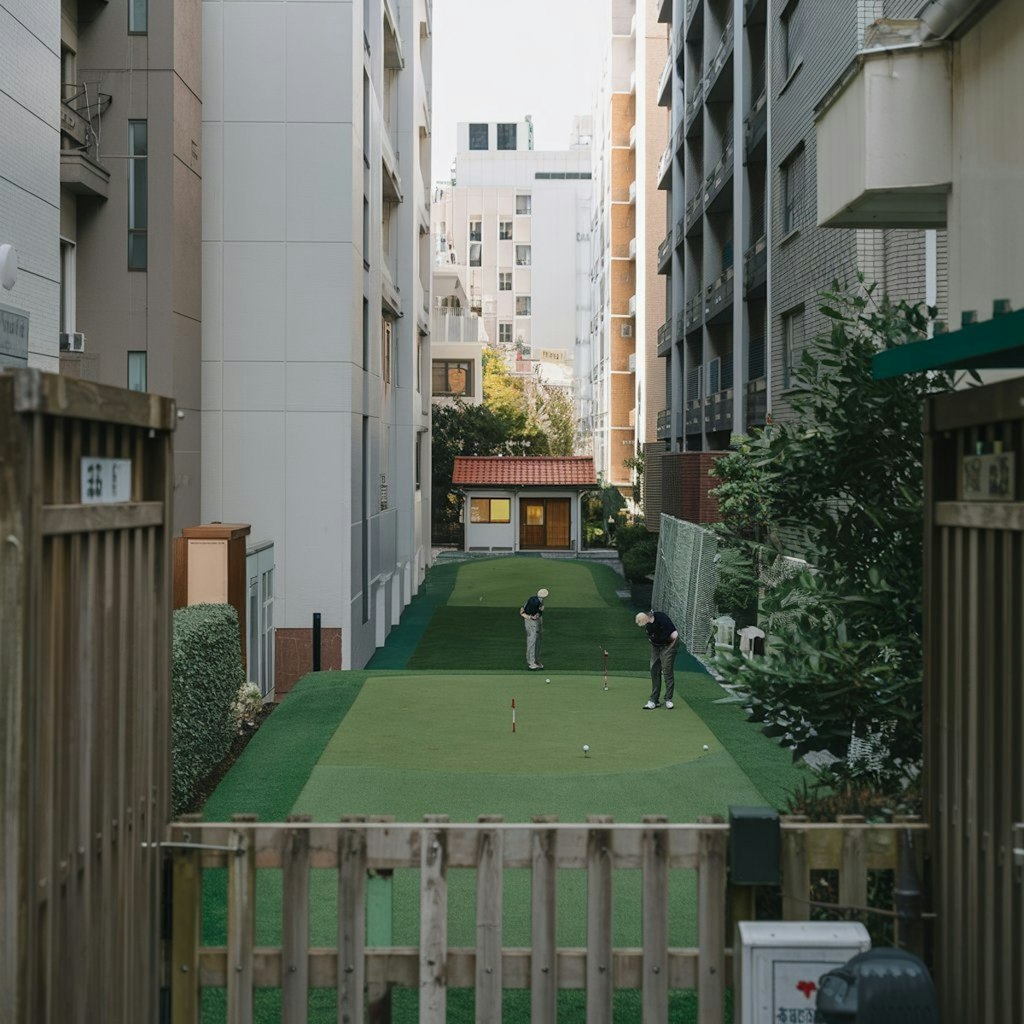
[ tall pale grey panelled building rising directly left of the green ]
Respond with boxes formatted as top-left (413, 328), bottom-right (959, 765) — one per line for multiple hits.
top-left (202, 0), bottom-right (432, 692)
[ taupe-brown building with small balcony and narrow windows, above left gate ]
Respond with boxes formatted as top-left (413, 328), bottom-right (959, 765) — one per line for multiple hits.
top-left (52, 0), bottom-right (202, 527)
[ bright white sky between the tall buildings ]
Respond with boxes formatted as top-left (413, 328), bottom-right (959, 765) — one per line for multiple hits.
top-left (431, 0), bottom-right (610, 181)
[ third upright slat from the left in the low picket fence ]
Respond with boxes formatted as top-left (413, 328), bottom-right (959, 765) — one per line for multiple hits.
top-left (284, 814), bottom-right (310, 1024)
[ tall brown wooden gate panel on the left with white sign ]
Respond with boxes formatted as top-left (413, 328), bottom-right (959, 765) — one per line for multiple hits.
top-left (0, 370), bottom-right (175, 1024)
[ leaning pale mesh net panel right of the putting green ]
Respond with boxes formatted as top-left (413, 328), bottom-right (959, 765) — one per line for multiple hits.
top-left (652, 512), bottom-right (718, 658)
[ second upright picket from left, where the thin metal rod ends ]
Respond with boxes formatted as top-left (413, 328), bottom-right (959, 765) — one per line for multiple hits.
top-left (227, 814), bottom-right (256, 1024)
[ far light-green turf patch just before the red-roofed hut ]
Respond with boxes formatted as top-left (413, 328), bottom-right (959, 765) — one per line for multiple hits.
top-left (447, 558), bottom-right (606, 610)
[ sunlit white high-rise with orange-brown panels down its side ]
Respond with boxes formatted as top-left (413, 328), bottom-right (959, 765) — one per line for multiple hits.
top-left (581, 0), bottom-right (668, 497)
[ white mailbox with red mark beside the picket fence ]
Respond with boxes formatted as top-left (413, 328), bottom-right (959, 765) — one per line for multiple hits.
top-left (733, 921), bottom-right (871, 1024)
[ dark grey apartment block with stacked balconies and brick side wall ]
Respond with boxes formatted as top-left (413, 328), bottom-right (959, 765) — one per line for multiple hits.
top-left (647, 0), bottom-right (945, 528)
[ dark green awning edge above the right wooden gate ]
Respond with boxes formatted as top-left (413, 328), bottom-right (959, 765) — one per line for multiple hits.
top-left (871, 309), bottom-right (1024, 380)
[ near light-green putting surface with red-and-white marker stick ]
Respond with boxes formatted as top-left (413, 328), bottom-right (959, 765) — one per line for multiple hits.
top-left (319, 672), bottom-right (719, 775)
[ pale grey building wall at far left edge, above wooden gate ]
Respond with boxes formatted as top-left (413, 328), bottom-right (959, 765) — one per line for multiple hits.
top-left (0, 0), bottom-right (60, 372)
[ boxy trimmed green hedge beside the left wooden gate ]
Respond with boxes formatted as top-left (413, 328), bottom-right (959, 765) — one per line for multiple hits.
top-left (171, 604), bottom-right (245, 814)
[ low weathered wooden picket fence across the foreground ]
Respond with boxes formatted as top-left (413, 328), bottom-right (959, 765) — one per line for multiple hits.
top-left (168, 815), bottom-right (924, 1024)
